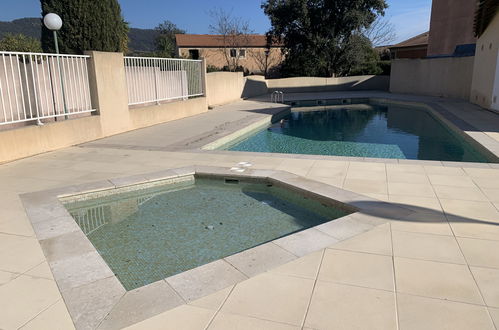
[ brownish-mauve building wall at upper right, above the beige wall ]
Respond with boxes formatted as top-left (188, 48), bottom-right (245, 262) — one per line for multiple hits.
top-left (428, 0), bottom-right (477, 56)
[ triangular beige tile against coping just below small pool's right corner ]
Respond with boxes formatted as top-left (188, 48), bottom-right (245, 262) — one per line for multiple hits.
top-left (330, 224), bottom-right (392, 256)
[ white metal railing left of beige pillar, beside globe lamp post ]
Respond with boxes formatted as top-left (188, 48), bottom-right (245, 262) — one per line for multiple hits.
top-left (0, 52), bottom-right (95, 125)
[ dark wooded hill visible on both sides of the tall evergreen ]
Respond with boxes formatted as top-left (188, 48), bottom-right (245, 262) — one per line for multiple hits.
top-left (0, 17), bottom-right (158, 53)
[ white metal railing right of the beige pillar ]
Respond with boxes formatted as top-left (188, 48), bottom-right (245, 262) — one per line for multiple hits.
top-left (125, 56), bottom-right (204, 105)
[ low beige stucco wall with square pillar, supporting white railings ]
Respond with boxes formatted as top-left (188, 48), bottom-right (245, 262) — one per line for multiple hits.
top-left (0, 52), bottom-right (208, 163)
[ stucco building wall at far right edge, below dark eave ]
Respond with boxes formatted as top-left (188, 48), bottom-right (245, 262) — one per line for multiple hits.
top-left (470, 14), bottom-right (499, 110)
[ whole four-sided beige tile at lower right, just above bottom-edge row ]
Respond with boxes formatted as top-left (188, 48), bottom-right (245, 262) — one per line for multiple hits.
top-left (395, 257), bottom-right (483, 304)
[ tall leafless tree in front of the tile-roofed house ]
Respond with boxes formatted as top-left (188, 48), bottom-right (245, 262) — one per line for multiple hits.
top-left (210, 8), bottom-right (252, 71)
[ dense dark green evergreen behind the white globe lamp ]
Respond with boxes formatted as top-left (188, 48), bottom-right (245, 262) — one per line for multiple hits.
top-left (40, 0), bottom-right (129, 54)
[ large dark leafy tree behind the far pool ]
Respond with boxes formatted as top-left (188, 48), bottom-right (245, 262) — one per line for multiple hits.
top-left (262, 0), bottom-right (387, 77)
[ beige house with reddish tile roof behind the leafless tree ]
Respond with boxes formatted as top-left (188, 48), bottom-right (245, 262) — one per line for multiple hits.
top-left (175, 34), bottom-right (282, 74)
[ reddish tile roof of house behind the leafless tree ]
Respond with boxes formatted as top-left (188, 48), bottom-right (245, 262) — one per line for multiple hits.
top-left (175, 34), bottom-right (278, 47)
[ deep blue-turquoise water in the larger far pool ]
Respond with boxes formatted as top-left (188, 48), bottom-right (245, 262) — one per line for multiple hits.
top-left (229, 104), bottom-right (490, 162)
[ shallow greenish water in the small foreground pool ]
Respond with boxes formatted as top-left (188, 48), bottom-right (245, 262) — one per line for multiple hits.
top-left (65, 179), bottom-right (347, 290)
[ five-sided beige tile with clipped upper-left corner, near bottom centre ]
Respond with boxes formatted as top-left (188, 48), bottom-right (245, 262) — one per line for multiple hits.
top-left (221, 273), bottom-right (314, 326)
